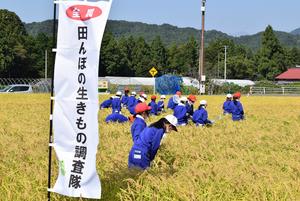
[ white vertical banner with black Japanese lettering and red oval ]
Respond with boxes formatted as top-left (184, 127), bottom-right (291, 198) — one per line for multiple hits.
top-left (49, 0), bottom-right (112, 199)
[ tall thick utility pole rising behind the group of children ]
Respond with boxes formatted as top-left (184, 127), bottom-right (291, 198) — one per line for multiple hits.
top-left (199, 0), bottom-right (206, 94)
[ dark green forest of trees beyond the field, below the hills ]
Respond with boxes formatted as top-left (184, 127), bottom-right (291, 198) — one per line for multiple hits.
top-left (0, 10), bottom-right (300, 80)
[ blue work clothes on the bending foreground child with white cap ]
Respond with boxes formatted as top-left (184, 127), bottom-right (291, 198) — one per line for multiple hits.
top-left (128, 127), bottom-right (165, 170)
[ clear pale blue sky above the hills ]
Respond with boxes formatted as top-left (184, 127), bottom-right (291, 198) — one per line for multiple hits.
top-left (0, 0), bottom-right (300, 35)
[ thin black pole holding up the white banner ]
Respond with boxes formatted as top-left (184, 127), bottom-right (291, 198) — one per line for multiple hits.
top-left (47, 0), bottom-right (56, 201)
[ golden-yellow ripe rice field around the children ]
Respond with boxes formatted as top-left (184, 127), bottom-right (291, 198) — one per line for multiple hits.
top-left (0, 94), bottom-right (300, 201)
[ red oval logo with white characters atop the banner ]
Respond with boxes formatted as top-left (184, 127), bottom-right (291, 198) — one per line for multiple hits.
top-left (66, 5), bottom-right (102, 21)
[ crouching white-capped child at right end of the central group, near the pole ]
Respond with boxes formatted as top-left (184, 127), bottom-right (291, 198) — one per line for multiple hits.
top-left (193, 100), bottom-right (213, 126)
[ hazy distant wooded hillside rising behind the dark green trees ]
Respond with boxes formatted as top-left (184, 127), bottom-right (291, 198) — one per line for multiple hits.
top-left (25, 20), bottom-right (300, 50)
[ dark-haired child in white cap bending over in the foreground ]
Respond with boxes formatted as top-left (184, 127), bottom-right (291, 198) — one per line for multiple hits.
top-left (128, 115), bottom-right (177, 170)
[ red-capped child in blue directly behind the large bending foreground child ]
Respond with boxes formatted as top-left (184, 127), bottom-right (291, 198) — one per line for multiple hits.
top-left (130, 103), bottom-right (151, 142)
